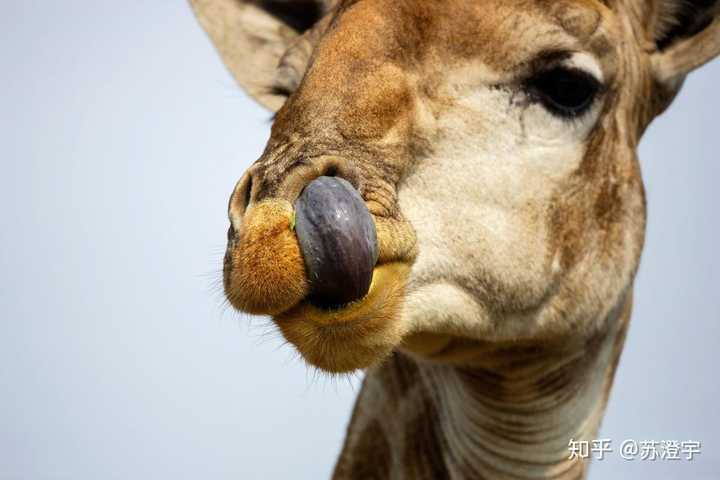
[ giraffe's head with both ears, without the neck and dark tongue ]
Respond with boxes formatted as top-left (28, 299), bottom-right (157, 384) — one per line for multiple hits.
top-left (192, 0), bottom-right (720, 372)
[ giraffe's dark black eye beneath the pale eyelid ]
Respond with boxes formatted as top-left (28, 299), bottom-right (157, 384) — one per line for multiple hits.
top-left (525, 67), bottom-right (602, 118)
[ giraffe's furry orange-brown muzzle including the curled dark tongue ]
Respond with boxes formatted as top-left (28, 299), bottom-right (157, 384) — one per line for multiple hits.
top-left (223, 163), bottom-right (417, 372)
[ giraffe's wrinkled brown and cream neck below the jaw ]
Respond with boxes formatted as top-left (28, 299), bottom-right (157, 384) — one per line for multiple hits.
top-left (333, 302), bottom-right (629, 480)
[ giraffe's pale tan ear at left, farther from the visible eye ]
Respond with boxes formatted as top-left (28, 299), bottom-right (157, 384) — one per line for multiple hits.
top-left (190, 0), bottom-right (323, 111)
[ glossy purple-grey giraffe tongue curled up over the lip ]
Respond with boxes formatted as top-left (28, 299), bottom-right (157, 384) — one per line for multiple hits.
top-left (295, 177), bottom-right (378, 308)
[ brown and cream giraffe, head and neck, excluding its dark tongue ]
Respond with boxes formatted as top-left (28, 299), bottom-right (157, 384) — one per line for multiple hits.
top-left (191, 0), bottom-right (720, 479)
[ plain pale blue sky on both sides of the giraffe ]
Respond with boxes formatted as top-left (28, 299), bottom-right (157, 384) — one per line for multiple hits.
top-left (0, 0), bottom-right (720, 480)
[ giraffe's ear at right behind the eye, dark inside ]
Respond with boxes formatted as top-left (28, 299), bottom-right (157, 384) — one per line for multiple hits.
top-left (650, 0), bottom-right (720, 86)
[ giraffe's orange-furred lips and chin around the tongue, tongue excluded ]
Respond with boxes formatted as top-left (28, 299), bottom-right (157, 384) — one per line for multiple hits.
top-left (223, 195), bottom-right (415, 373)
